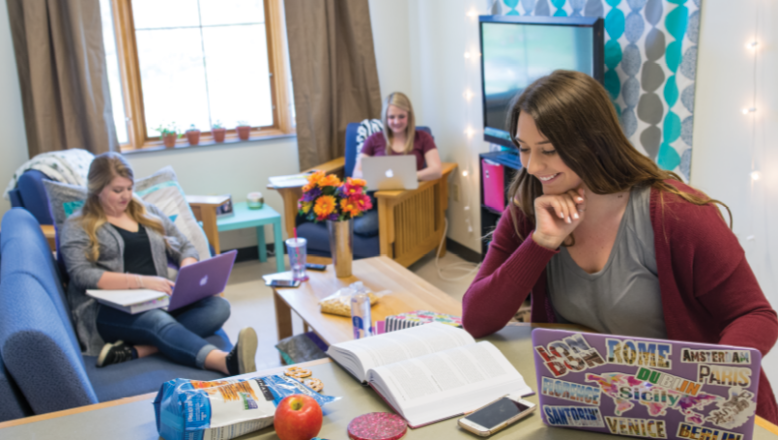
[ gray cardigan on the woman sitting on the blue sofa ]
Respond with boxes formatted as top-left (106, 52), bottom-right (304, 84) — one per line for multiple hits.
top-left (59, 204), bottom-right (198, 356)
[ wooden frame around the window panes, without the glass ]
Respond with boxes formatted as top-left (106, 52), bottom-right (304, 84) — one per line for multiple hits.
top-left (111, 0), bottom-right (295, 151)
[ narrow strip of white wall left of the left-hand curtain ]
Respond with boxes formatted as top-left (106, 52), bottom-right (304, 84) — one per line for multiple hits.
top-left (0, 0), bottom-right (28, 218)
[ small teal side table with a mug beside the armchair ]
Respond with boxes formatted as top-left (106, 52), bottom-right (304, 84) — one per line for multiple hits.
top-left (216, 202), bottom-right (286, 272)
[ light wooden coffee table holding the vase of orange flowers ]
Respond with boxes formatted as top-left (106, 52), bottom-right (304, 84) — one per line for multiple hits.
top-left (273, 256), bottom-right (462, 345)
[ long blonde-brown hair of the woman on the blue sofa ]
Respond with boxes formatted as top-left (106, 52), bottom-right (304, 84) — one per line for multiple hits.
top-left (80, 152), bottom-right (165, 261)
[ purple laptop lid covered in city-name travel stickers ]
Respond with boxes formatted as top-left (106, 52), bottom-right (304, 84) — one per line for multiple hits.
top-left (532, 328), bottom-right (762, 440)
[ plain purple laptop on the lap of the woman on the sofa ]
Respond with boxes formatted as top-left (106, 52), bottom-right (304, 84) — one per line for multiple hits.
top-left (166, 250), bottom-right (238, 311)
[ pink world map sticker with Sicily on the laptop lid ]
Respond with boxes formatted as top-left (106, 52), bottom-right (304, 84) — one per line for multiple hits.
top-left (586, 373), bottom-right (721, 425)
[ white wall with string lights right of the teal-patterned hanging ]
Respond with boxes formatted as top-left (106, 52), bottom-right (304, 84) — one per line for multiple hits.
top-left (691, 0), bottom-right (778, 389)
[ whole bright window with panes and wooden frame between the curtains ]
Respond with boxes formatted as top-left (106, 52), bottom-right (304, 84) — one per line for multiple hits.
top-left (101, 0), bottom-right (294, 150)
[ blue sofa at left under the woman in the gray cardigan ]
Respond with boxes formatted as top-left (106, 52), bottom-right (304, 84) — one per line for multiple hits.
top-left (0, 208), bottom-right (232, 417)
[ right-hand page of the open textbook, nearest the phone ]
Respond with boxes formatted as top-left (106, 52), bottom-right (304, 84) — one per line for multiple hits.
top-left (368, 342), bottom-right (532, 425)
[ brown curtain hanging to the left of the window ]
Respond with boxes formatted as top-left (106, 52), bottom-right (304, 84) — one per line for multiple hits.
top-left (7, 0), bottom-right (118, 157)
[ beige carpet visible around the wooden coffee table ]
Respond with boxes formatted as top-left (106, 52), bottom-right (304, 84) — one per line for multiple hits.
top-left (215, 252), bottom-right (475, 371)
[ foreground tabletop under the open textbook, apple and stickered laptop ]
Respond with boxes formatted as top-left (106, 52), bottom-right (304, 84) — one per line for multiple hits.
top-left (0, 324), bottom-right (778, 440)
